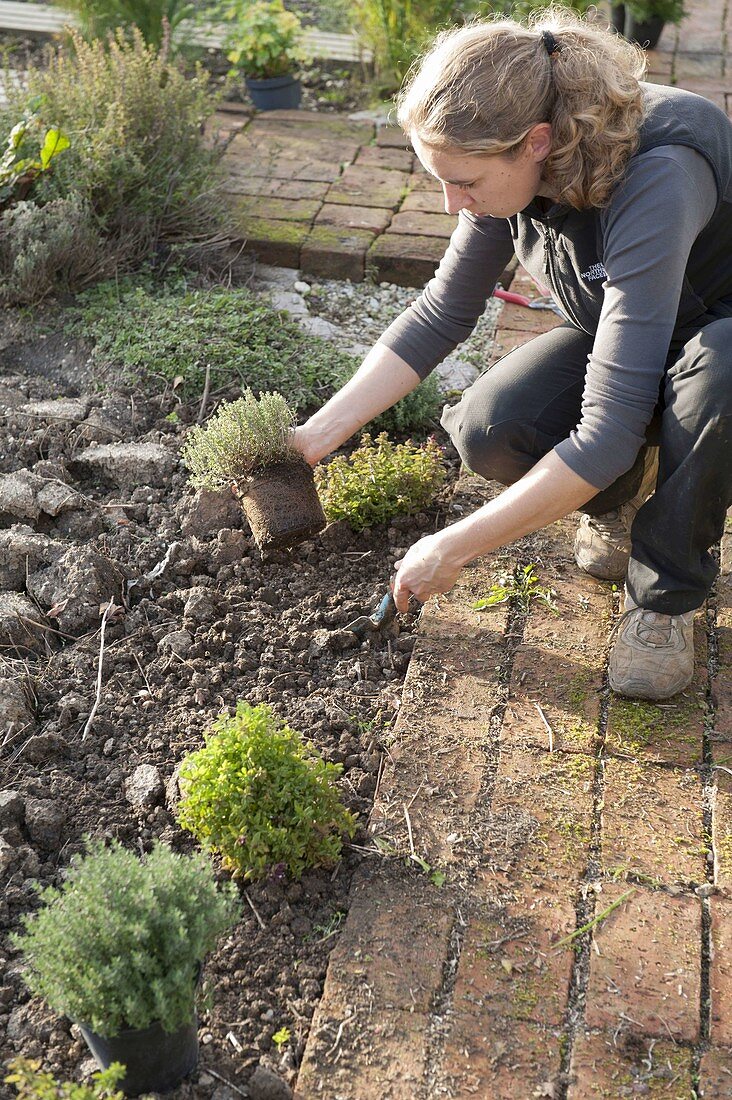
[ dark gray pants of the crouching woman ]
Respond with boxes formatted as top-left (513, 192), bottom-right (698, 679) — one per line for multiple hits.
top-left (443, 315), bottom-right (732, 615)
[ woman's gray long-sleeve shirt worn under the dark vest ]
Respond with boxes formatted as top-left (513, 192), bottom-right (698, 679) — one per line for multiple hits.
top-left (381, 141), bottom-right (717, 490)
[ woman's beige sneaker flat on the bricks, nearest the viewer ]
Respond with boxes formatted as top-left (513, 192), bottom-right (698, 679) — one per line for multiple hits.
top-left (609, 594), bottom-right (696, 700)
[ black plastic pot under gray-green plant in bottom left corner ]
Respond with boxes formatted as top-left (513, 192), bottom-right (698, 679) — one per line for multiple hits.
top-left (79, 1019), bottom-right (198, 1097)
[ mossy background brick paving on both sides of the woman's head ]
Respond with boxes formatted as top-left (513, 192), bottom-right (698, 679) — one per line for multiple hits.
top-left (217, 0), bottom-right (732, 286)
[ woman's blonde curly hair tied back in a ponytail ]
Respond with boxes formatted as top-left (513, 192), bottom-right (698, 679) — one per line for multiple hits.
top-left (397, 6), bottom-right (645, 209)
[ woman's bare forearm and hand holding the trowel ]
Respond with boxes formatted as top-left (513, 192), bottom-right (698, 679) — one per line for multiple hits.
top-left (394, 451), bottom-right (598, 612)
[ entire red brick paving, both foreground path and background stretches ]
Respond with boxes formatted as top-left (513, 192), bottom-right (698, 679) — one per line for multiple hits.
top-left (229, 0), bottom-right (732, 1100)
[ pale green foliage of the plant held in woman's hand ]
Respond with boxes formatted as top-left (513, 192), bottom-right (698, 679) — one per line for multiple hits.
top-left (182, 389), bottom-right (301, 490)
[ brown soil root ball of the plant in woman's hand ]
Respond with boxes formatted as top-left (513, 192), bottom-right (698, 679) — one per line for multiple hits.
top-left (237, 460), bottom-right (326, 550)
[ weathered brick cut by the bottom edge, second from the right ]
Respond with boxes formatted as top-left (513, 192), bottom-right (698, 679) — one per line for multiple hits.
top-left (567, 1030), bottom-right (693, 1100)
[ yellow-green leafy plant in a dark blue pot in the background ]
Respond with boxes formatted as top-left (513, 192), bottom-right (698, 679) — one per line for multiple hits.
top-left (221, 0), bottom-right (305, 111)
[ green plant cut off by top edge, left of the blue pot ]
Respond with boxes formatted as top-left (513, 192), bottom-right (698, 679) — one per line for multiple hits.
top-left (54, 0), bottom-right (196, 48)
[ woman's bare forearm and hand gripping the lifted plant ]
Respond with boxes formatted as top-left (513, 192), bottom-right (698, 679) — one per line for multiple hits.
top-left (294, 343), bottom-right (422, 465)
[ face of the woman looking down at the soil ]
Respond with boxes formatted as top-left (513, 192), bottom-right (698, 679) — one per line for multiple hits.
top-left (412, 122), bottom-right (551, 218)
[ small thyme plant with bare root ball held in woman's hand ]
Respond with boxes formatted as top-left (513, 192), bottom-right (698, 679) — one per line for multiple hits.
top-left (183, 389), bottom-right (326, 550)
